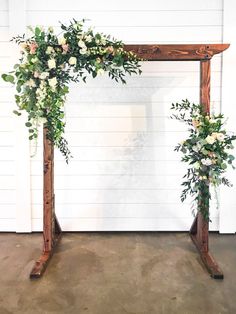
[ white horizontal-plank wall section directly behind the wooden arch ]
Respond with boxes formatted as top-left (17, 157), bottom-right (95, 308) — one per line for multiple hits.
top-left (0, 0), bottom-right (236, 232)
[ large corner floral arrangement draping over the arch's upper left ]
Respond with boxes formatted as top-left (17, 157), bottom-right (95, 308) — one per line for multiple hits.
top-left (2, 20), bottom-right (141, 162)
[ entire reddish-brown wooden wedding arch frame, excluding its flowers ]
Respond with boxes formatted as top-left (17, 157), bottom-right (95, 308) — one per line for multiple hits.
top-left (30, 44), bottom-right (229, 279)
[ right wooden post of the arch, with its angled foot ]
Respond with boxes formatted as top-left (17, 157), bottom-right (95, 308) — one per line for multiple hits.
top-left (190, 60), bottom-right (224, 279)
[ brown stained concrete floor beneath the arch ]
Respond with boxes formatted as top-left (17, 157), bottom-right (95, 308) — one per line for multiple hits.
top-left (0, 233), bottom-right (236, 314)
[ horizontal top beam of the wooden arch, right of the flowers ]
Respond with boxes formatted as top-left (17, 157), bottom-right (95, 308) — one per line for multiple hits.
top-left (125, 44), bottom-right (229, 61)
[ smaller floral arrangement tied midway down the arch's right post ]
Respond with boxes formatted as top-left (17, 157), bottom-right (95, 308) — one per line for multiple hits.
top-left (171, 100), bottom-right (236, 220)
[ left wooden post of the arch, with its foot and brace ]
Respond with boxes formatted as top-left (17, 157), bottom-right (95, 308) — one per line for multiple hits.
top-left (30, 128), bottom-right (61, 279)
